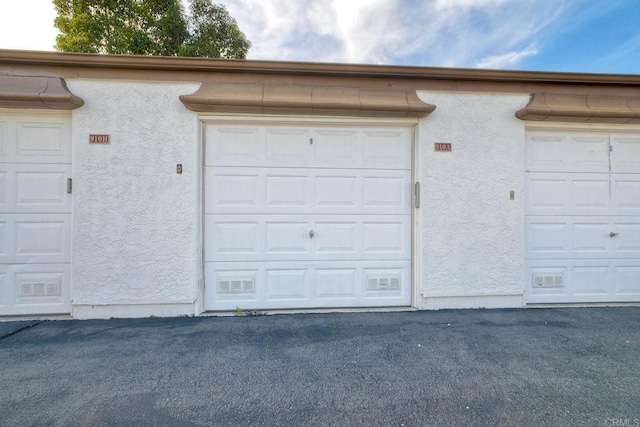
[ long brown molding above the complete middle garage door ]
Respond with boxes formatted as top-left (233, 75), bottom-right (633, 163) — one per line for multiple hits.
top-left (180, 82), bottom-right (436, 118)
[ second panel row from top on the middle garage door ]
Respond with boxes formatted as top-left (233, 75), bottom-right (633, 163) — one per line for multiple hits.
top-left (205, 167), bottom-right (412, 214)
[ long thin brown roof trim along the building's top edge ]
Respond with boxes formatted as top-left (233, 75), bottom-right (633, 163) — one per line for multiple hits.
top-left (0, 49), bottom-right (640, 86)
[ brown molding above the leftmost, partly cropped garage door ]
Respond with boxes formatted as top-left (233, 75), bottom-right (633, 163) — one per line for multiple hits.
top-left (0, 76), bottom-right (84, 110)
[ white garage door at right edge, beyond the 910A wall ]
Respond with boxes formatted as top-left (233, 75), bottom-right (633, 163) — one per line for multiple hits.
top-left (526, 130), bottom-right (640, 303)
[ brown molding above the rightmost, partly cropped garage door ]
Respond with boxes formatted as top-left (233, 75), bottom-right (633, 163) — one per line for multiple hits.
top-left (516, 93), bottom-right (640, 123)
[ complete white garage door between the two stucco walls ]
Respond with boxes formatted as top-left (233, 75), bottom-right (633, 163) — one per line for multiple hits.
top-left (204, 123), bottom-right (413, 310)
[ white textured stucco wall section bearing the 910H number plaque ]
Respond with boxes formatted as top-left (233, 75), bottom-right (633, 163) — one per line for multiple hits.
top-left (67, 80), bottom-right (200, 317)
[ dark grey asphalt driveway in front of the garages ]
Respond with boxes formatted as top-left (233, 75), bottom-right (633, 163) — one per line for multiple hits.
top-left (0, 307), bottom-right (640, 427)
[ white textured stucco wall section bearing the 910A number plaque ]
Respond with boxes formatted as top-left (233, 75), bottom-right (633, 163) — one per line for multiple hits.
top-left (418, 91), bottom-right (529, 308)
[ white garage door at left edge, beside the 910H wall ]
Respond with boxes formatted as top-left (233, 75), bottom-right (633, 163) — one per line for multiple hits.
top-left (0, 112), bottom-right (71, 315)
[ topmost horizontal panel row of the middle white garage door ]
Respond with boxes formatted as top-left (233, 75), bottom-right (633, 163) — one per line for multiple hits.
top-left (205, 125), bottom-right (412, 170)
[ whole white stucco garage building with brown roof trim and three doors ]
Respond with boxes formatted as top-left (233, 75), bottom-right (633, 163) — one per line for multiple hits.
top-left (0, 50), bottom-right (640, 318)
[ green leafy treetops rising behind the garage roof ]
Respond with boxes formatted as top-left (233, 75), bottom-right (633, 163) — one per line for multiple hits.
top-left (53, 0), bottom-right (251, 59)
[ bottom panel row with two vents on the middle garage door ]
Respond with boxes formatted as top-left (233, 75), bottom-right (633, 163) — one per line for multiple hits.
top-left (205, 260), bottom-right (411, 310)
